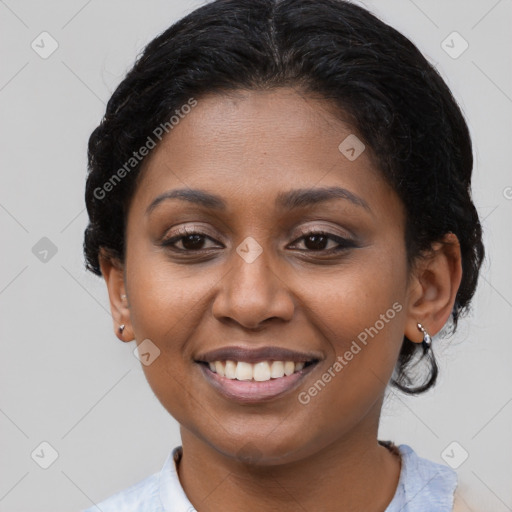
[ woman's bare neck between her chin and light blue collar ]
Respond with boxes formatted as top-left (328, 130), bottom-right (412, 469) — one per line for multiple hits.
top-left (179, 422), bottom-right (400, 512)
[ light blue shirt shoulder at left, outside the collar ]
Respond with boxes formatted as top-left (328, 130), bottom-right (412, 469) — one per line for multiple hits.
top-left (83, 473), bottom-right (162, 512)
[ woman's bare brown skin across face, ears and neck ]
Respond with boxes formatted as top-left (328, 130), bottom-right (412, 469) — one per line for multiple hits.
top-left (101, 88), bottom-right (462, 512)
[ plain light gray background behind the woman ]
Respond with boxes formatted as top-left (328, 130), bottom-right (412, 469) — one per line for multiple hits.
top-left (0, 0), bottom-right (512, 512)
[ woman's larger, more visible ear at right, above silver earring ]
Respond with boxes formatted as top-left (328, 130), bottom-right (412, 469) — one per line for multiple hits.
top-left (404, 233), bottom-right (462, 343)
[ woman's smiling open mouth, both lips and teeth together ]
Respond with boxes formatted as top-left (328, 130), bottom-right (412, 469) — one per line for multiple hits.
top-left (195, 347), bottom-right (322, 403)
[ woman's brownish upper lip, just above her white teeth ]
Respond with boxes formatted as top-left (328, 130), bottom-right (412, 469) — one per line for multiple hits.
top-left (196, 346), bottom-right (321, 363)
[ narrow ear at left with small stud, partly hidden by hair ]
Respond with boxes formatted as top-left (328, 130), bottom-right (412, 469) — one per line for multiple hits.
top-left (99, 249), bottom-right (134, 342)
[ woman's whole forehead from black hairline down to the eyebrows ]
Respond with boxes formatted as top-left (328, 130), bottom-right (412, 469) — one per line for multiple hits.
top-left (128, 88), bottom-right (396, 222)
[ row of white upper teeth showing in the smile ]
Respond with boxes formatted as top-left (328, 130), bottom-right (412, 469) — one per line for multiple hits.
top-left (208, 360), bottom-right (304, 382)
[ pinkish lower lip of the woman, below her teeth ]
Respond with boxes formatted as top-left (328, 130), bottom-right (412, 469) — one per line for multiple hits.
top-left (199, 364), bottom-right (316, 403)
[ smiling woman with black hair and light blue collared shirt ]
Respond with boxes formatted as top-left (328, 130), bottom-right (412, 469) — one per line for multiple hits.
top-left (84, 0), bottom-right (484, 512)
